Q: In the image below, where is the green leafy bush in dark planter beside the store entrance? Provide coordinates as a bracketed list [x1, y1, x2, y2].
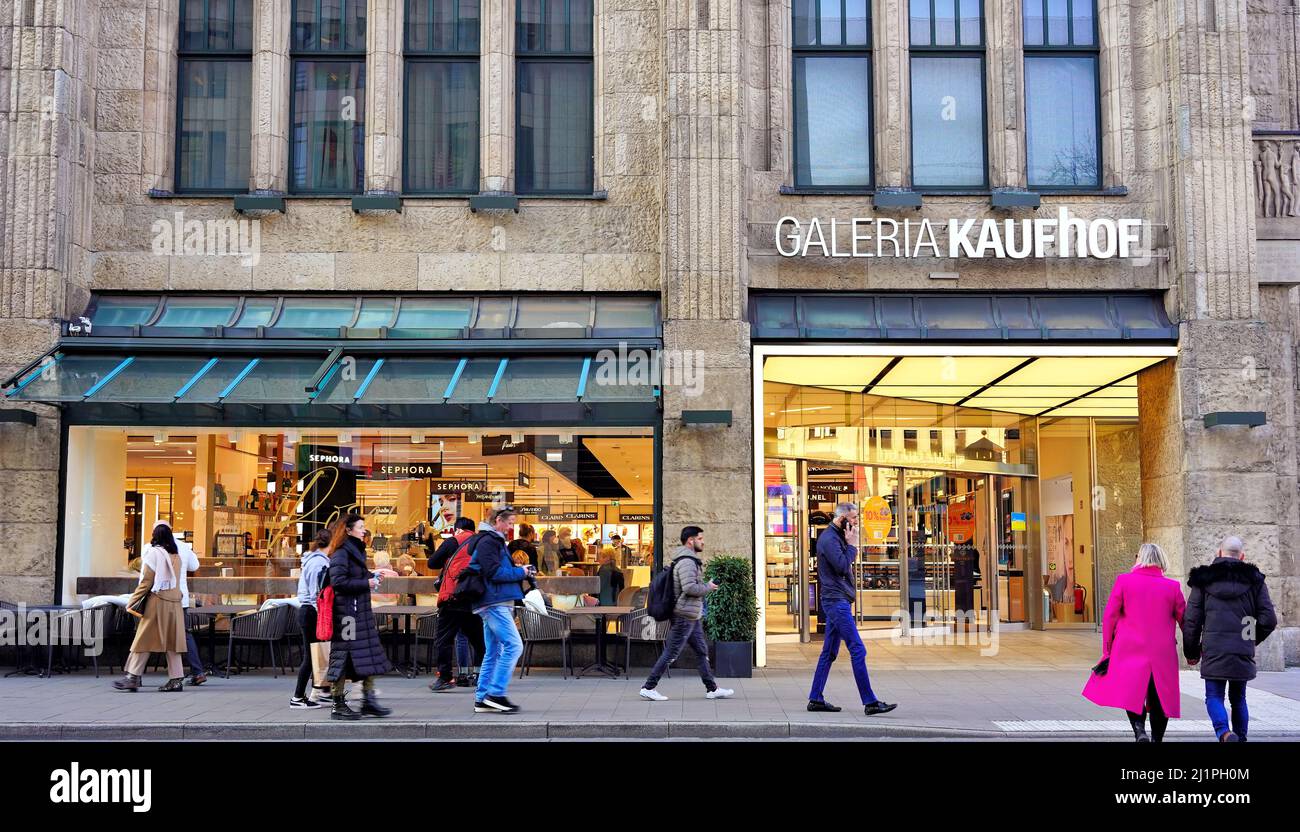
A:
[705, 555, 758, 679]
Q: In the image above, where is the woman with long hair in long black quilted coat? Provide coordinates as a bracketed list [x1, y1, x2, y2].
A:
[325, 514, 393, 719]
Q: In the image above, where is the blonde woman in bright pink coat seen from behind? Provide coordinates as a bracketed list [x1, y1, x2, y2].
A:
[1083, 543, 1187, 742]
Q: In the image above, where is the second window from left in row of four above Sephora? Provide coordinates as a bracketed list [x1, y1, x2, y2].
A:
[289, 0, 365, 194]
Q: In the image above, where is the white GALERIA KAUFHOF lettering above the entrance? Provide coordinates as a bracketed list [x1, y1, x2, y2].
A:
[776, 208, 1143, 260]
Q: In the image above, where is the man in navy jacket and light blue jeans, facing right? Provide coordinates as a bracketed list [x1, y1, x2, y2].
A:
[467, 507, 536, 714]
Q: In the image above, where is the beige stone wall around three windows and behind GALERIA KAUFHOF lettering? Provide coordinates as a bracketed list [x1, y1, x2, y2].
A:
[745, 0, 1173, 291]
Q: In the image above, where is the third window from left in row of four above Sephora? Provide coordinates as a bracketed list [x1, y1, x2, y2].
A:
[402, 0, 478, 194]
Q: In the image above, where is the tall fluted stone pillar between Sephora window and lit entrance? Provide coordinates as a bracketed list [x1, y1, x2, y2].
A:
[662, 0, 767, 555]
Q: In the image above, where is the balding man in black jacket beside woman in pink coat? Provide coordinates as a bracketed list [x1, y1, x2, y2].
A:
[1183, 537, 1278, 742]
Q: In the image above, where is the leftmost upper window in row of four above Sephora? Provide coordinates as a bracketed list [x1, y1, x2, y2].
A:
[176, 0, 252, 192]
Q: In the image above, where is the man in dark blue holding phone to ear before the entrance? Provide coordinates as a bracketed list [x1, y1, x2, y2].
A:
[809, 503, 898, 716]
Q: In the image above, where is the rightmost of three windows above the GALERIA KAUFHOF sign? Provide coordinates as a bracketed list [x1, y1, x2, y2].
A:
[1023, 0, 1101, 189]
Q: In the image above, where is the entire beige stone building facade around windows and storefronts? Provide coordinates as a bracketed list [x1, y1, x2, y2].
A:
[0, 0, 1300, 666]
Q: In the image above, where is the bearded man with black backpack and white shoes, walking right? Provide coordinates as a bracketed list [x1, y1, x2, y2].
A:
[641, 525, 736, 702]
